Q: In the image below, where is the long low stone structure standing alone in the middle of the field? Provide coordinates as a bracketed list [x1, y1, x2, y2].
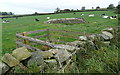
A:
[44, 18, 86, 24]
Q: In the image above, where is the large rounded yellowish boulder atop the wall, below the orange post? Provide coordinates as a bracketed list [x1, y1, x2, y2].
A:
[12, 47, 31, 61]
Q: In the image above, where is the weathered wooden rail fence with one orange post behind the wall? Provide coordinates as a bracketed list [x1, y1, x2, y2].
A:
[16, 29, 83, 50]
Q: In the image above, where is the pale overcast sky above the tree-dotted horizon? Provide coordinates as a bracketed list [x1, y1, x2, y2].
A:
[0, 0, 120, 14]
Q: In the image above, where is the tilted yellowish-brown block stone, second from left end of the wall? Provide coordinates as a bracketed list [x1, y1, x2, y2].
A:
[1, 53, 19, 67]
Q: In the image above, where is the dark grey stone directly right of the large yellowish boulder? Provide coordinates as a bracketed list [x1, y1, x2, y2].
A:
[28, 51, 44, 66]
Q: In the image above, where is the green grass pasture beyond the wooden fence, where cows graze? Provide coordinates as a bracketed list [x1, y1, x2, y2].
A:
[2, 11, 118, 54]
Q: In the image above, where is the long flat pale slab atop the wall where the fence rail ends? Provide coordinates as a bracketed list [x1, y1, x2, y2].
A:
[54, 44, 77, 52]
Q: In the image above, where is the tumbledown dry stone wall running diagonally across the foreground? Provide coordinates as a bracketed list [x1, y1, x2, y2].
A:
[0, 27, 118, 74]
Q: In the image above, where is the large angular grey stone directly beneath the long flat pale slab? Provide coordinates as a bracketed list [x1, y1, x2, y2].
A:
[55, 49, 71, 63]
